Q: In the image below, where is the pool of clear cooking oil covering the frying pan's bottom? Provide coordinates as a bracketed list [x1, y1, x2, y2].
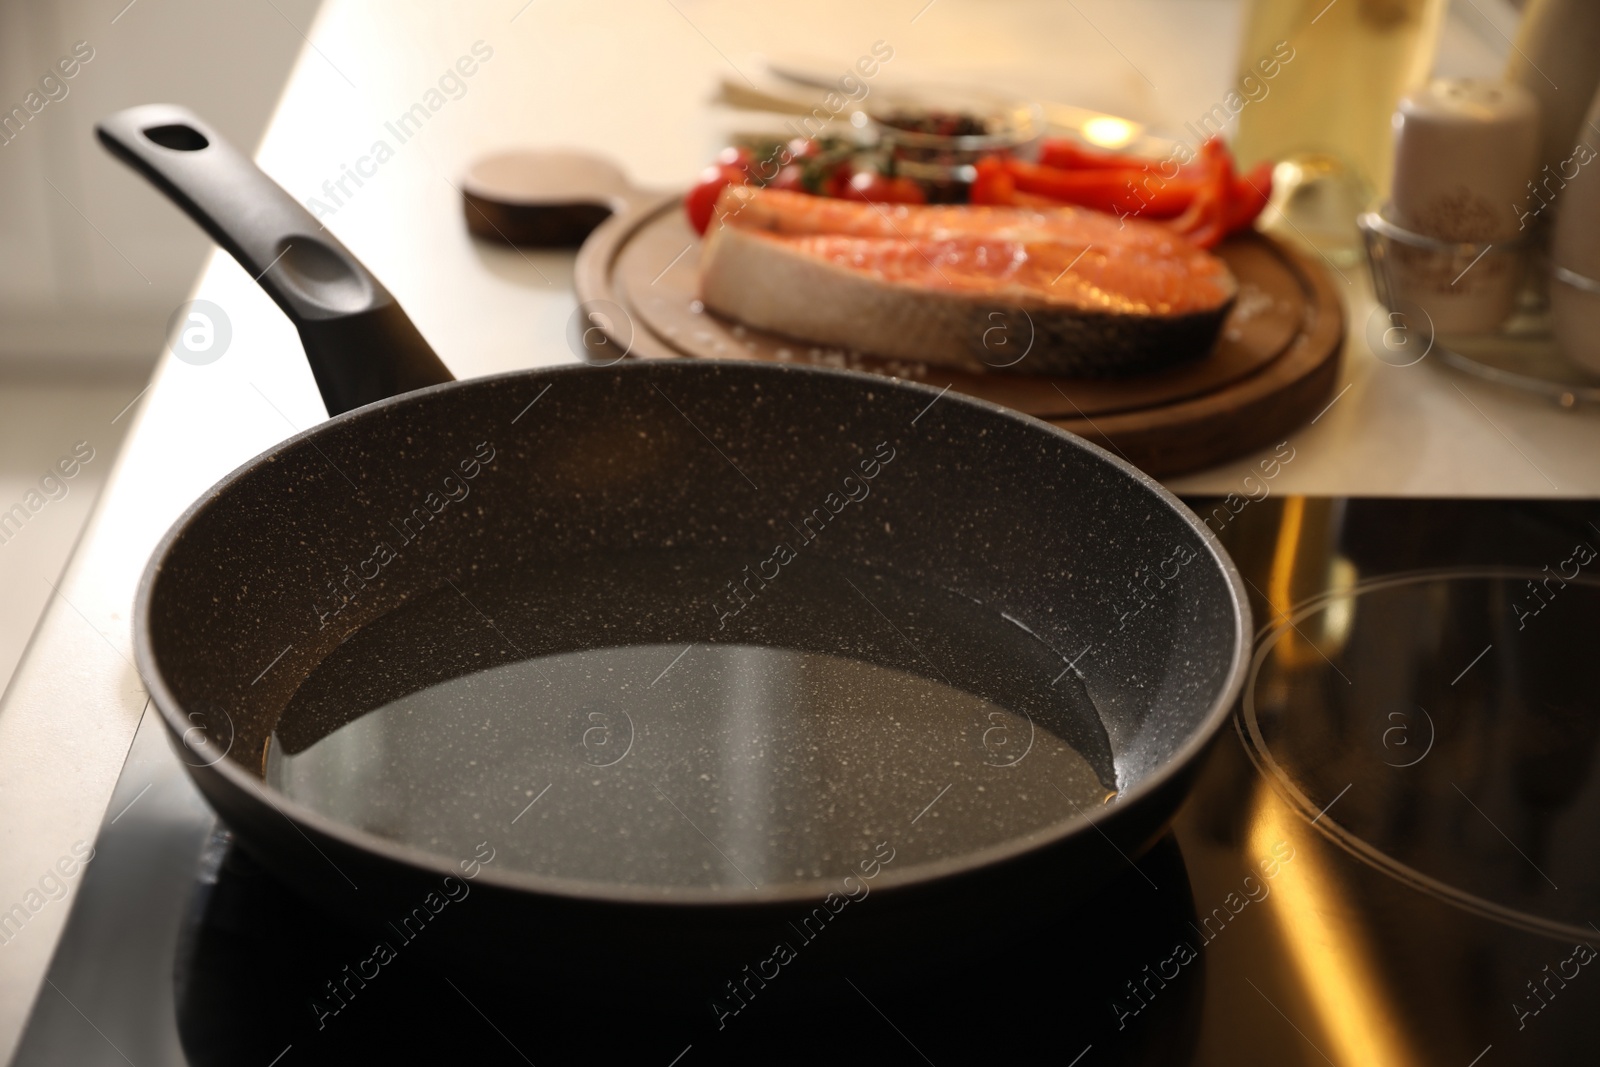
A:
[264, 553, 1114, 888]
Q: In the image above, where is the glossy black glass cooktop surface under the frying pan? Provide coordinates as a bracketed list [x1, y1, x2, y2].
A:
[16, 496, 1600, 1067]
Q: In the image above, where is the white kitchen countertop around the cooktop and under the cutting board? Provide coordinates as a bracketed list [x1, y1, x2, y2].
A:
[0, 0, 1600, 1061]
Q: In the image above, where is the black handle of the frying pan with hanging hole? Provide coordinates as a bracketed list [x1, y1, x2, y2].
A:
[94, 104, 453, 414]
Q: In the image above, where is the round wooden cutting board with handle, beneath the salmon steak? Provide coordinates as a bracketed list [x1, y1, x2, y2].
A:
[466, 152, 1344, 477]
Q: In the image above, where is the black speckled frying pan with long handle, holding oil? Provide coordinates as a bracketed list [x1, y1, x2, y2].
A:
[98, 106, 1251, 968]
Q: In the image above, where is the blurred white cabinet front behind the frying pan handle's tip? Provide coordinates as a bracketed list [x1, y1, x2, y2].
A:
[0, 0, 317, 375]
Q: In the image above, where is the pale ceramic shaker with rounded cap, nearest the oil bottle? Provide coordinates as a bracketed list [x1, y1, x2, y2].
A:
[1387, 78, 1539, 334]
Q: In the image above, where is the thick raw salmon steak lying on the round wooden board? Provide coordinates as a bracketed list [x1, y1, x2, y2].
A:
[701, 186, 1238, 378]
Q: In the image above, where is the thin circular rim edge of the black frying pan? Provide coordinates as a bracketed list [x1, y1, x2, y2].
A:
[133, 358, 1253, 910]
